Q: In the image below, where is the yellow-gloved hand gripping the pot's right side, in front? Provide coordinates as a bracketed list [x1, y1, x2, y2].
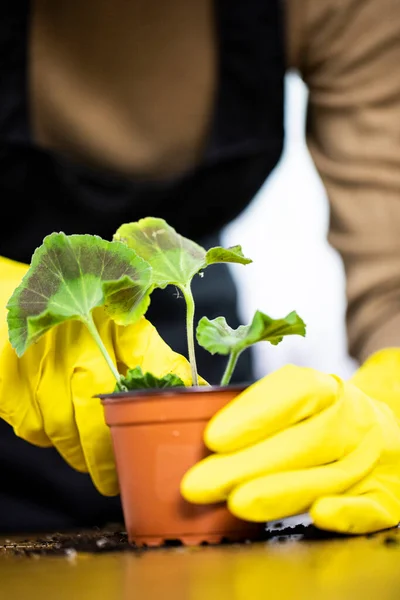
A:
[181, 349, 400, 534]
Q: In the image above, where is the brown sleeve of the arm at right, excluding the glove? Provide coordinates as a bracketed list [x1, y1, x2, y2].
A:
[287, 0, 400, 361]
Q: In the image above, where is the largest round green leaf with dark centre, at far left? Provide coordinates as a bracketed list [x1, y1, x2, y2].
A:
[7, 233, 152, 356]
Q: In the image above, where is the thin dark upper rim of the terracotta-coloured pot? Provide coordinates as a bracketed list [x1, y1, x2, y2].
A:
[94, 381, 254, 402]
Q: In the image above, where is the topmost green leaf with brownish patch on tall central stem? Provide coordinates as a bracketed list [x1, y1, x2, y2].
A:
[114, 217, 251, 288]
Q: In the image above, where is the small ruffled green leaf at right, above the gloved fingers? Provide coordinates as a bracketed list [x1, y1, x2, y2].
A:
[196, 311, 306, 355]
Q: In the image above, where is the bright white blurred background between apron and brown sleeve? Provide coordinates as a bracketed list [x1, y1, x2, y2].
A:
[223, 73, 357, 378]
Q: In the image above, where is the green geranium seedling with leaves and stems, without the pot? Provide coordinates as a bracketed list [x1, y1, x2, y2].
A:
[7, 217, 306, 391]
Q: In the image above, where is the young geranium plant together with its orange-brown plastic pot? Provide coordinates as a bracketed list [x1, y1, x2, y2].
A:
[8, 217, 305, 546]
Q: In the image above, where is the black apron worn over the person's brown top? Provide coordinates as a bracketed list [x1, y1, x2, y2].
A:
[0, 0, 284, 533]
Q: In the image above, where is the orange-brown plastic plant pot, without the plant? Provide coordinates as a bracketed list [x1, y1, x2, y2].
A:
[100, 386, 265, 546]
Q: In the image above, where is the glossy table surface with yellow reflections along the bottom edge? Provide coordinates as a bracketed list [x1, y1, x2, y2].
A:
[0, 529, 400, 600]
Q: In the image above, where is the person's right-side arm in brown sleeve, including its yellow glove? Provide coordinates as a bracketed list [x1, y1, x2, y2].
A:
[181, 0, 400, 535]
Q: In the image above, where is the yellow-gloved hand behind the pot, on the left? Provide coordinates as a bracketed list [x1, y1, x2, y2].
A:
[0, 258, 191, 495]
